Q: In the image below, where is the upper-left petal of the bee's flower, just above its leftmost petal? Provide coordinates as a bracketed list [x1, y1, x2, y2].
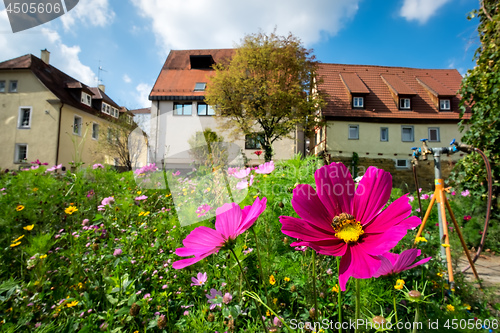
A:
[292, 184, 334, 231]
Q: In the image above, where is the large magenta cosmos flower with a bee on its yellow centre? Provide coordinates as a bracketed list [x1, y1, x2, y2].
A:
[280, 163, 421, 290]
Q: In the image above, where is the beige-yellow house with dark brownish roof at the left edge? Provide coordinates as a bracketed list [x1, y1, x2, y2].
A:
[0, 50, 133, 169]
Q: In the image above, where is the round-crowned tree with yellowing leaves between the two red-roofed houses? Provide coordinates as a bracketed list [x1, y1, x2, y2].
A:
[205, 32, 324, 161]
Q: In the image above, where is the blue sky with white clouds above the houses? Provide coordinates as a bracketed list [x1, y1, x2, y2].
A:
[0, 0, 479, 109]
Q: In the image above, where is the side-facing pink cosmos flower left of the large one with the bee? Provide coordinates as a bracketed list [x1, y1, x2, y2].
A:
[172, 197, 267, 269]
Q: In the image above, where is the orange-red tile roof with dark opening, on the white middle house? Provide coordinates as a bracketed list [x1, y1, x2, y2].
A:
[149, 49, 234, 99]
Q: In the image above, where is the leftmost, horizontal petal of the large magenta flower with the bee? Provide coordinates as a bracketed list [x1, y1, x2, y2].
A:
[280, 216, 335, 242]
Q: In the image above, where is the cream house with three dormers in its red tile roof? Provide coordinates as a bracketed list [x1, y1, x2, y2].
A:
[313, 64, 468, 186]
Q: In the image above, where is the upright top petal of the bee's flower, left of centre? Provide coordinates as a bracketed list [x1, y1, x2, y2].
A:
[314, 162, 355, 216]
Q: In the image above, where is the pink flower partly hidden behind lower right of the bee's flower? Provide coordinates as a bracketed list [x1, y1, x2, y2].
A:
[373, 249, 432, 277]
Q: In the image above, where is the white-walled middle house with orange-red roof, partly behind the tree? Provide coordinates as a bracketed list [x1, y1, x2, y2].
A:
[149, 49, 304, 168]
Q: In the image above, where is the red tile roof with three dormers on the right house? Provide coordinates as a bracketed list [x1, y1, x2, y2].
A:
[319, 64, 467, 121]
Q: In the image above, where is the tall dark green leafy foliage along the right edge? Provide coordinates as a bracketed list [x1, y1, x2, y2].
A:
[455, 0, 500, 197]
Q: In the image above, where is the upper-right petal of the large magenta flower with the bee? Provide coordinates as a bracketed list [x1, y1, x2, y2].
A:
[353, 166, 392, 224]
